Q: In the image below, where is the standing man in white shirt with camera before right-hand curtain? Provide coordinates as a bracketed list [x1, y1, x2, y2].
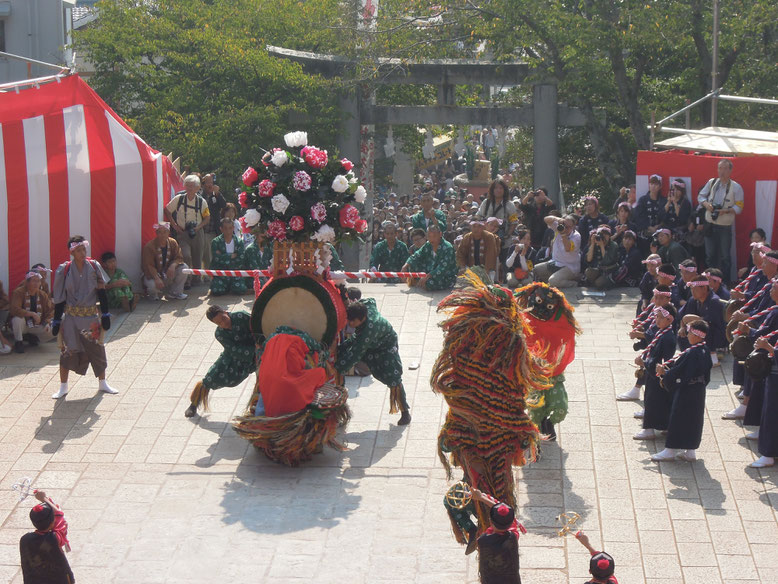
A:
[697, 159, 743, 282]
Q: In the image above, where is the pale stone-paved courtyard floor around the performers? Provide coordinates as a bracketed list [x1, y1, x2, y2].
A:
[0, 284, 778, 584]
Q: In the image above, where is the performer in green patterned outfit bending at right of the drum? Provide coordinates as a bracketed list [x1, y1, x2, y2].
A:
[335, 298, 411, 426]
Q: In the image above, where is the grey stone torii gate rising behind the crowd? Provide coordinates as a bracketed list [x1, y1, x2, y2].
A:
[267, 46, 586, 266]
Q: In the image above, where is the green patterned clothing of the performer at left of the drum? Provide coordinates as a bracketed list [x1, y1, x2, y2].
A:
[203, 310, 257, 389]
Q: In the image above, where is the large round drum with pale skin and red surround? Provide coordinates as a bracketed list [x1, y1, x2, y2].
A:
[251, 274, 346, 346]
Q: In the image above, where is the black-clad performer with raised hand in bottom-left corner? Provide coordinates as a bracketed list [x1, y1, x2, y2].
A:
[19, 491, 75, 584]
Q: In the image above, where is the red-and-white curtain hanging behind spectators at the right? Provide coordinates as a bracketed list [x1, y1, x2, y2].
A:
[635, 150, 778, 266]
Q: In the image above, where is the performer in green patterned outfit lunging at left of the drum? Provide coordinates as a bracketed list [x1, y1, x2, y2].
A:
[184, 304, 257, 418]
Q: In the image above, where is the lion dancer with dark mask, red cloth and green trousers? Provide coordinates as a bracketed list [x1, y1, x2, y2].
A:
[515, 282, 581, 440]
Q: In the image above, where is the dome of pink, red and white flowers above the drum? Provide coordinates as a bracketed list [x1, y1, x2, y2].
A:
[238, 132, 367, 243]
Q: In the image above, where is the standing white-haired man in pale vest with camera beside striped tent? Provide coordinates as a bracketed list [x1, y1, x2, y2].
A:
[165, 174, 211, 289]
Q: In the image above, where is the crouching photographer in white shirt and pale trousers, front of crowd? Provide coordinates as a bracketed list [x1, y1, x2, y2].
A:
[534, 215, 581, 288]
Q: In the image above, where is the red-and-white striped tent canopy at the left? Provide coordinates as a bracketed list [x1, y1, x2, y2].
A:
[0, 75, 182, 290]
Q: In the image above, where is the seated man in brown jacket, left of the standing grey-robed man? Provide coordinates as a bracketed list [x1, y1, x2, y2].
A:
[11, 272, 54, 353]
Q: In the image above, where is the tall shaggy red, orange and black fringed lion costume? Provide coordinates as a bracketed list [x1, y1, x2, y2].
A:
[430, 271, 550, 543]
